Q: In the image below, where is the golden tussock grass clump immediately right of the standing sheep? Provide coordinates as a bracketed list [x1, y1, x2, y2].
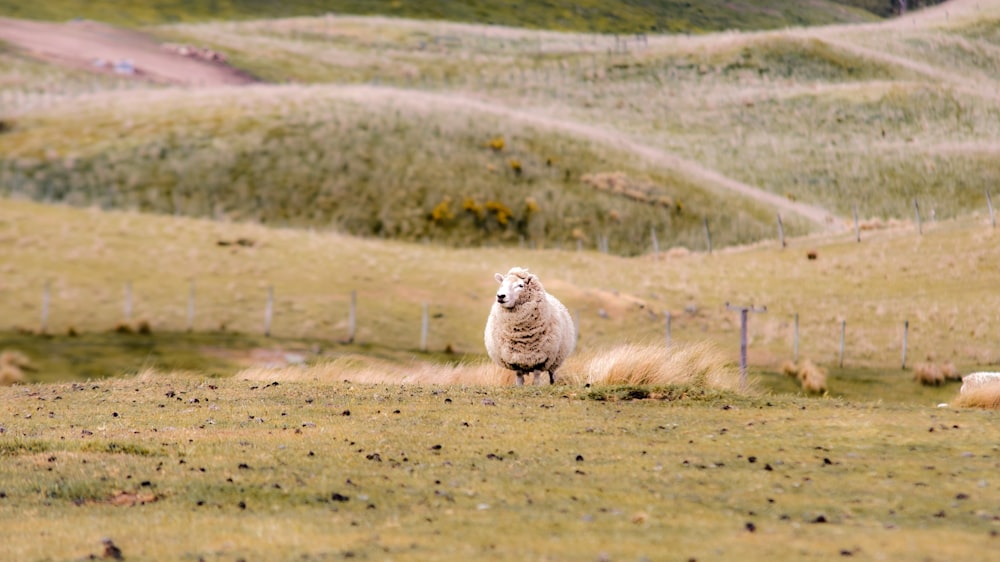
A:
[561, 342, 740, 391]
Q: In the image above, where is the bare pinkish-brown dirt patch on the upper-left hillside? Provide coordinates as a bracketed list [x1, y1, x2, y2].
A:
[0, 18, 254, 86]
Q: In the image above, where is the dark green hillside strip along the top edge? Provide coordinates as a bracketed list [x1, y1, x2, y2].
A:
[0, 0, 876, 33]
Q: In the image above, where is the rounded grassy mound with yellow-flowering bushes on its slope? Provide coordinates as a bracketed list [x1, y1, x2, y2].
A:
[0, 87, 788, 254]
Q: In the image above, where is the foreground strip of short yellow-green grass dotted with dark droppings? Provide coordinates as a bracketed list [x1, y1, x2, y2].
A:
[0, 375, 1000, 560]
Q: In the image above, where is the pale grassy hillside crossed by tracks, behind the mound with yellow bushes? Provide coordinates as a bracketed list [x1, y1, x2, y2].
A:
[156, 3, 1000, 218]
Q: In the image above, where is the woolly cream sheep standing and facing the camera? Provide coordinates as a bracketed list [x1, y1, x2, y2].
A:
[485, 267, 576, 386]
